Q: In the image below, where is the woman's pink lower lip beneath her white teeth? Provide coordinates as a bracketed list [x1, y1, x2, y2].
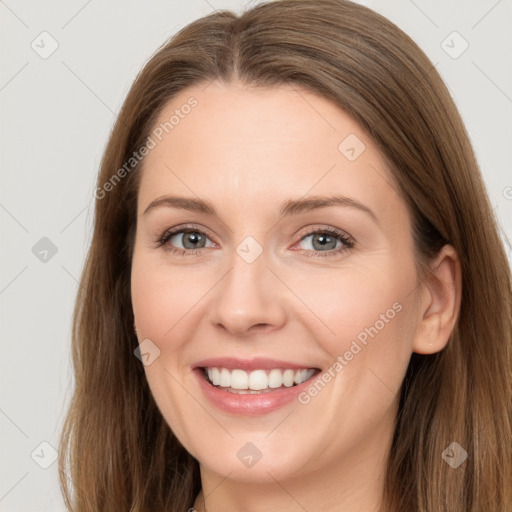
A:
[193, 368, 316, 416]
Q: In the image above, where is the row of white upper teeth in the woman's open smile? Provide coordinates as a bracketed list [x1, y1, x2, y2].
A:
[207, 368, 315, 391]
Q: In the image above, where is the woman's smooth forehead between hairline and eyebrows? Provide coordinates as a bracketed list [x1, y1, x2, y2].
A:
[139, 81, 400, 219]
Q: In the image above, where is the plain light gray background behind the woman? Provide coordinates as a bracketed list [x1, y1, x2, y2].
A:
[0, 0, 512, 512]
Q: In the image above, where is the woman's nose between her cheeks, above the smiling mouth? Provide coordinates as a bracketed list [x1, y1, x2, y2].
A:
[210, 246, 287, 337]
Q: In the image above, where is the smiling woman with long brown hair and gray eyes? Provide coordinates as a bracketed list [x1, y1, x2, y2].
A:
[60, 0, 512, 512]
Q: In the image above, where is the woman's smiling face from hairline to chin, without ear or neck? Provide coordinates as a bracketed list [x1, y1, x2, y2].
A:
[131, 82, 420, 482]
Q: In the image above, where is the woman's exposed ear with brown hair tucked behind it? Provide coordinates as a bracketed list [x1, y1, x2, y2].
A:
[413, 245, 462, 354]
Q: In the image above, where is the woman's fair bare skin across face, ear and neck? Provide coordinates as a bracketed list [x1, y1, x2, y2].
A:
[131, 81, 460, 512]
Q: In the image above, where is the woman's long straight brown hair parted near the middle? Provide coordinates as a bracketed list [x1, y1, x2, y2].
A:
[59, 0, 512, 512]
